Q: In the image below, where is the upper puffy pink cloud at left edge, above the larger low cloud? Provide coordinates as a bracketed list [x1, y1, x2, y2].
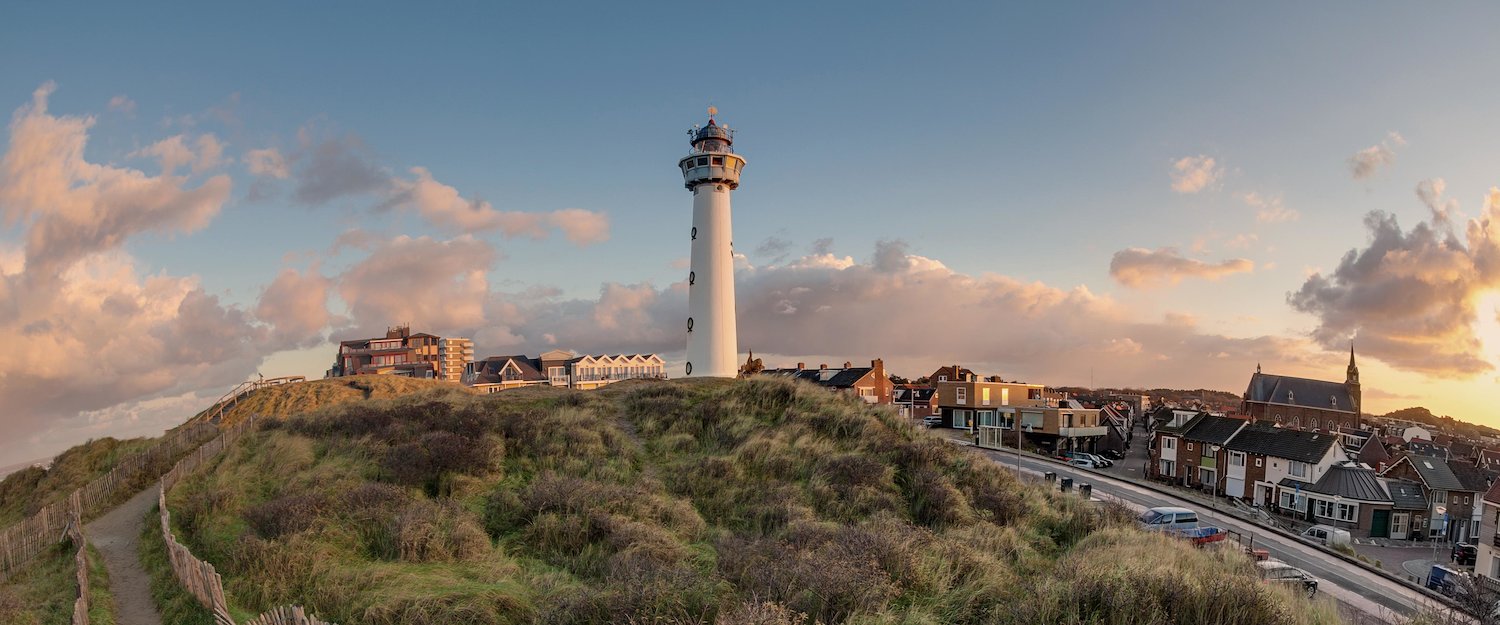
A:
[0, 82, 230, 276]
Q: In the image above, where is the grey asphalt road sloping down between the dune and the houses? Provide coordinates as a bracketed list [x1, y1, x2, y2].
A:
[954, 440, 1446, 621]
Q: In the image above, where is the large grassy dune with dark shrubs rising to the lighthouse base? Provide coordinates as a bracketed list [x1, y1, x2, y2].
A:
[161, 374, 1338, 625]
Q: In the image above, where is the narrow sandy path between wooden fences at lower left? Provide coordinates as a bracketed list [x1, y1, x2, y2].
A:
[84, 484, 162, 625]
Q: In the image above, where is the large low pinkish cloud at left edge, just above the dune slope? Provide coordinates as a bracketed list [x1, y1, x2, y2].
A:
[0, 250, 264, 459]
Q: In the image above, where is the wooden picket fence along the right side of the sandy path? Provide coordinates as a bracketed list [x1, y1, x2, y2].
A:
[156, 417, 332, 625]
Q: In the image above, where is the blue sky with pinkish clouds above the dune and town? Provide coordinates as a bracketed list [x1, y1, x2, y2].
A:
[0, 3, 1500, 465]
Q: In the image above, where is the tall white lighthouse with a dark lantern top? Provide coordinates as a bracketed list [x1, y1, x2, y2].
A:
[677, 106, 746, 378]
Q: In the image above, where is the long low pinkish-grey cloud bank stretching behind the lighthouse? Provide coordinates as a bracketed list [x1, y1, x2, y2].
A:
[423, 241, 1340, 387]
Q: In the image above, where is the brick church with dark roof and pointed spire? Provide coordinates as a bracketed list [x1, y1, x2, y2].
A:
[1239, 345, 1361, 430]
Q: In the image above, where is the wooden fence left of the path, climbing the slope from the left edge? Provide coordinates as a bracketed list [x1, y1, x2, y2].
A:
[0, 424, 218, 582]
